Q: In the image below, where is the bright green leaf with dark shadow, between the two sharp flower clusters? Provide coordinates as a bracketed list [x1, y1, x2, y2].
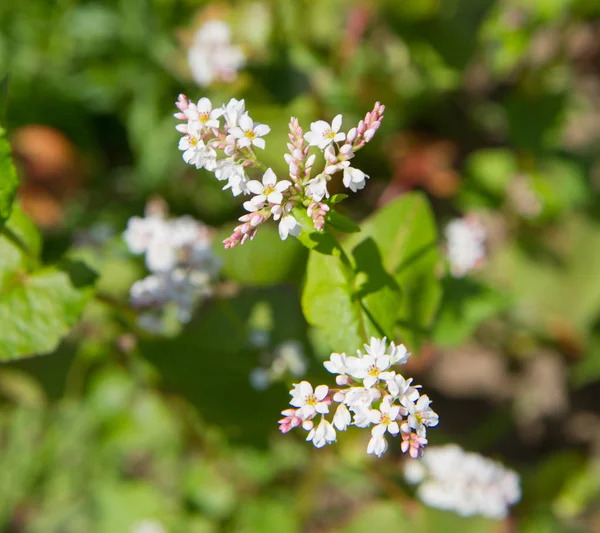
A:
[302, 194, 441, 353]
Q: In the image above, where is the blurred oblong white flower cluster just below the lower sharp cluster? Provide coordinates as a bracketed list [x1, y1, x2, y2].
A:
[404, 444, 521, 519]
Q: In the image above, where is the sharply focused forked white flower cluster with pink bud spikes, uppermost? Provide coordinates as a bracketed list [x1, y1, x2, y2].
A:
[175, 95, 385, 248]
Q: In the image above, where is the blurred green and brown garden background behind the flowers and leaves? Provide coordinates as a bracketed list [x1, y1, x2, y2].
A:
[0, 0, 600, 533]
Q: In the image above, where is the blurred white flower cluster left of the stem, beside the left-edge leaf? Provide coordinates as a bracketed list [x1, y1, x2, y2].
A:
[123, 201, 220, 332]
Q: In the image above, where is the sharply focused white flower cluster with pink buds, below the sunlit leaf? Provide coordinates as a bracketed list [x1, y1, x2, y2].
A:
[279, 338, 438, 458]
